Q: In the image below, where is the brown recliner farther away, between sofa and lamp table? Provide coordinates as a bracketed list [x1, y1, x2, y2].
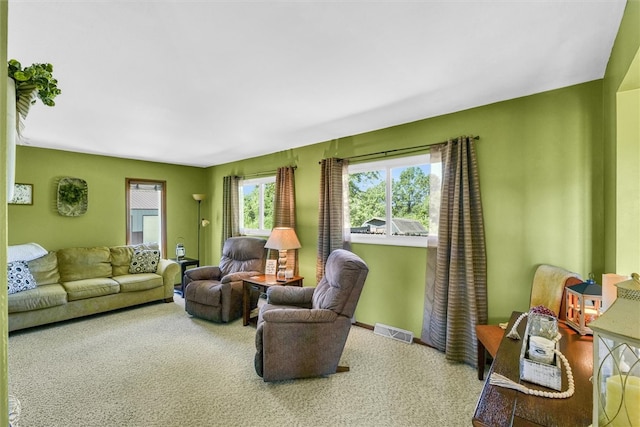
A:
[184, 237, 266, 323]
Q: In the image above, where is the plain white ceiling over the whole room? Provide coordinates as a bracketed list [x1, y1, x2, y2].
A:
[8, 0, 626, 167]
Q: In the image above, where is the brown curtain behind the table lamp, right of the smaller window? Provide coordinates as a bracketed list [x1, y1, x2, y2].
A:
[273, 166, 300, 276]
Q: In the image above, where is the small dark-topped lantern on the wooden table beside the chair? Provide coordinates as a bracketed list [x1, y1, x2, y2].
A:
[565, 277, 602, 335]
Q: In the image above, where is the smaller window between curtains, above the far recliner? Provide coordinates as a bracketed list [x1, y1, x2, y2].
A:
[238, 176, 276, 236]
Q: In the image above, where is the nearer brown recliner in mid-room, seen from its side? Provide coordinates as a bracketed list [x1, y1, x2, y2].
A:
[255, 249, 369, 381]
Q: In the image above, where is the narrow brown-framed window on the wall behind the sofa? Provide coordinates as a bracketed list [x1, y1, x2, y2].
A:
[126, 178, 167, 256]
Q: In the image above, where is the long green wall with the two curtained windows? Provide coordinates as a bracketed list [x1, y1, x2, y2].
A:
[208, 81, 603, 330]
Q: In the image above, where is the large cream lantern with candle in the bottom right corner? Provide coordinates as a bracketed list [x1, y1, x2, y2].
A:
[589, 273, 640, 427]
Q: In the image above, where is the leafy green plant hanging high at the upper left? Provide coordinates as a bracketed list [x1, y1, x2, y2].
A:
[8, 59, 62, 130]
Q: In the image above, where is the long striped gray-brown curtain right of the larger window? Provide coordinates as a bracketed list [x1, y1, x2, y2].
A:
[421, 137, 487, 366]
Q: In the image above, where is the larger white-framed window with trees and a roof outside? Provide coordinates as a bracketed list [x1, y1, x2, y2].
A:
[348, 154, 442, 247]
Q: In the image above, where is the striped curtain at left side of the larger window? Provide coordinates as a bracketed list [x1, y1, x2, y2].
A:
[316, 158, 349, 282]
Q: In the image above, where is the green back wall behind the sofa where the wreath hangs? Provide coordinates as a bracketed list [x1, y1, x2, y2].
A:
[8, 147, 207, 258]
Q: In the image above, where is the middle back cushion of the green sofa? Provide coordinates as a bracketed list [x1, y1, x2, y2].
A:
[57, 246, 112, 282]
